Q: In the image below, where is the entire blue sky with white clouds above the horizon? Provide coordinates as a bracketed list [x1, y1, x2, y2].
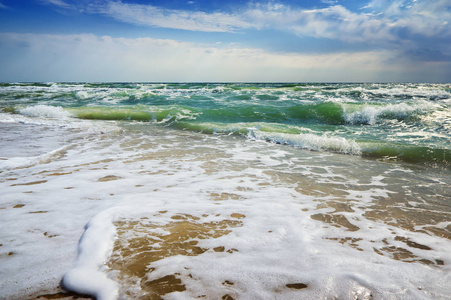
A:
[0, 0, 451, 83]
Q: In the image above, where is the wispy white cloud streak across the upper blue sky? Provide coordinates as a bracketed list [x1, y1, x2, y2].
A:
[42, 0, 451, 47]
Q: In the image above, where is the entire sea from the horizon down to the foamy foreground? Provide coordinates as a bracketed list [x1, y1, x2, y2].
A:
[0, 83, 451, 299]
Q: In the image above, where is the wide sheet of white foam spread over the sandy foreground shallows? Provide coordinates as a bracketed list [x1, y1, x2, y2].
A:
[0, 126, 451, 299]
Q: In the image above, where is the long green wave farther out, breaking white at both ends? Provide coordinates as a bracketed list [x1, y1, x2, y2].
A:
[10, 102, 434, 125]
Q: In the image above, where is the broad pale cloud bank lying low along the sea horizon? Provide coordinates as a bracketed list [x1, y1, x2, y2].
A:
[0, 33, 451, 82]
